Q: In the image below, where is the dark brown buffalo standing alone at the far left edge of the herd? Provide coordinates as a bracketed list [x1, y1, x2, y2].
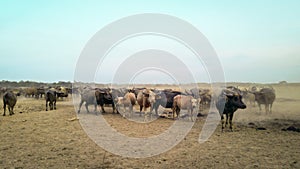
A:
[3, 91, 17, 116]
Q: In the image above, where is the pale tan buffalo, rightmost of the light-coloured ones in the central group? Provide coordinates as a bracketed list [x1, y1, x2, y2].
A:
[173, 95, 198, 121]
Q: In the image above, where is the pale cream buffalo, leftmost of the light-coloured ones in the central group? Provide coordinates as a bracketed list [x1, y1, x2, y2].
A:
[116, 93, 136, 117]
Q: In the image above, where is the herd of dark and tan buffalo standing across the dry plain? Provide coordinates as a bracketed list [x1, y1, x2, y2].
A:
[0, 86, 276, 131]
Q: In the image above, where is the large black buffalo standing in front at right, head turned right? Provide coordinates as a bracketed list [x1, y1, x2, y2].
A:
[216, 89, 246, 131]
